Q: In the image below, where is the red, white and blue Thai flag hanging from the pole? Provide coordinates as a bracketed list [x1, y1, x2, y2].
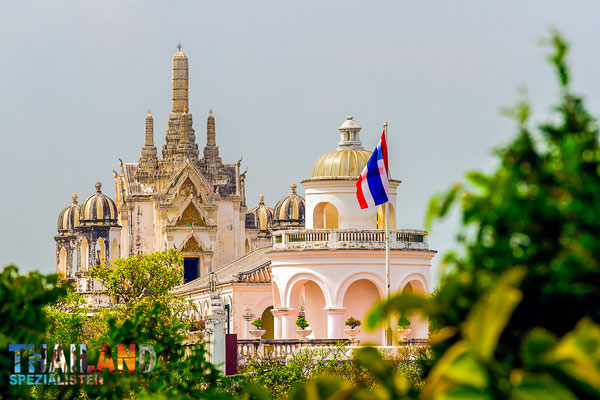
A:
[356, 131, 388, 208]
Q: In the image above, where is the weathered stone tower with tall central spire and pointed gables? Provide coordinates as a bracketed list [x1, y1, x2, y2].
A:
[114, 44, 252, 281]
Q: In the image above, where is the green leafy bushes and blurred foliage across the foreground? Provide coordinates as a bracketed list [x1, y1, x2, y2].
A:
[0, 32, 600, 400]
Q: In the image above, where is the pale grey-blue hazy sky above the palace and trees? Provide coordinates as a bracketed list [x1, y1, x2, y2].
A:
[0, 0, 600, 280]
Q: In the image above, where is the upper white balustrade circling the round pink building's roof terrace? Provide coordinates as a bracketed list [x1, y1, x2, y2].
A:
[273, 229, 429, 250]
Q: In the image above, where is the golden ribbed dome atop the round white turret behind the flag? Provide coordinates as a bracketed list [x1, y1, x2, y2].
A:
[310, 149, 371, 178]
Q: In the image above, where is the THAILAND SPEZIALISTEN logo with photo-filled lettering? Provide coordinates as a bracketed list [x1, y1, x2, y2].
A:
[8, 344, 156, 385]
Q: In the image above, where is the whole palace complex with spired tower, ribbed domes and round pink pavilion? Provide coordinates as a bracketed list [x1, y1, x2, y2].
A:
[55, 43, 435, 344]
